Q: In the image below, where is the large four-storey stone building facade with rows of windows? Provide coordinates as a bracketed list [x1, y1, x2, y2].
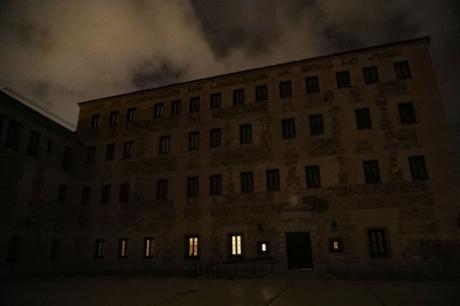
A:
[2, 38, 460, 273]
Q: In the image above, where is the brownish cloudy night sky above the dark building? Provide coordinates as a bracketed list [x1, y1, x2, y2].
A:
[0, 0, 460, 144]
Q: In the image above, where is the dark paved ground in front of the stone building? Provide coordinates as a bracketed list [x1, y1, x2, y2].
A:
[0, 276, 460, 306]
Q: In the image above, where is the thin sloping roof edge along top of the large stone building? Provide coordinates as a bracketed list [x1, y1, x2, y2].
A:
[78, 36, 431, 105]
